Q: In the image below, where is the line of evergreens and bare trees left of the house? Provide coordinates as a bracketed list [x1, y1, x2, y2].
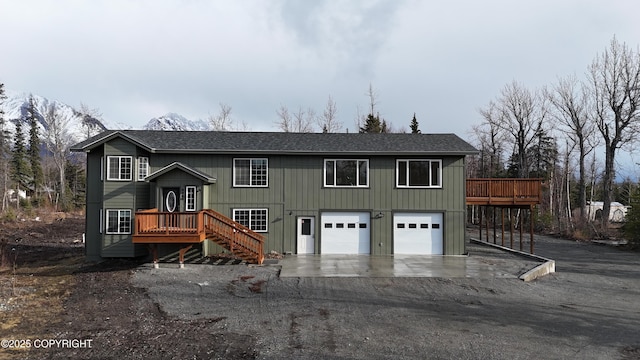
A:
[0, 83, 89, 212]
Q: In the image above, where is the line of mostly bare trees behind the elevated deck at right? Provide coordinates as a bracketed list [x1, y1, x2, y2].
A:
[468, 37, 640, 236]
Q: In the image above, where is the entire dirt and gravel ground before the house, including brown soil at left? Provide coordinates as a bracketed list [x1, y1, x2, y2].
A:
[5, 218, 640, 359]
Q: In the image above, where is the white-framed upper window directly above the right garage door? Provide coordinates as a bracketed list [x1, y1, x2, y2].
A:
[396, 159, 442, 188]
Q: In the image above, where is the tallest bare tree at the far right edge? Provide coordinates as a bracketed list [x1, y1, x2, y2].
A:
[588, 37, 640, 228]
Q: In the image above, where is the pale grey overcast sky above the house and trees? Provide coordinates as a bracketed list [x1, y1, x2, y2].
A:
[0, 0, 640, 138]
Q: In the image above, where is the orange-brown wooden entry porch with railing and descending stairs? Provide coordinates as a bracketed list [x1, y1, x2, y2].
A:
[132, 209, 264, 266]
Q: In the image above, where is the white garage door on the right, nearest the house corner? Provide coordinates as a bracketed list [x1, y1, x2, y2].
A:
[393, 213, 443, 255]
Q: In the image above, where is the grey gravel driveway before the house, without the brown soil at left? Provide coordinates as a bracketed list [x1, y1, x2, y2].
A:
[133, 236, 640, 359]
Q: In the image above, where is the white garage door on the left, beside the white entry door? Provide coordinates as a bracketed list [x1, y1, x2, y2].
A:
[320, 212, 371, 254]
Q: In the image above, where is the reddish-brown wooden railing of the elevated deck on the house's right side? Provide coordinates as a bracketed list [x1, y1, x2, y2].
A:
[467, 178, 542, 207]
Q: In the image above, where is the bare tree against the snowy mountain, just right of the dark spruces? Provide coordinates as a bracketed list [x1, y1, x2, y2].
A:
[45, 104, 72, 205]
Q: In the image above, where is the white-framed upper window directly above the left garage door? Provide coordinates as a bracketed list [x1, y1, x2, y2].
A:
[324, 159, 369, 187]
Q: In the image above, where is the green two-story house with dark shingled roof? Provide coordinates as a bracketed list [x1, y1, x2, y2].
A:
[72, 130, 477, 259]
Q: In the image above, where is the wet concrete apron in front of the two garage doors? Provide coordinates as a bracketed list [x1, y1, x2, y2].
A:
[278, 239, 540, 278]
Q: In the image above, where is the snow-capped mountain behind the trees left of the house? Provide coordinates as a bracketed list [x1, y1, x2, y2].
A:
[2, 90, 107, 144]
